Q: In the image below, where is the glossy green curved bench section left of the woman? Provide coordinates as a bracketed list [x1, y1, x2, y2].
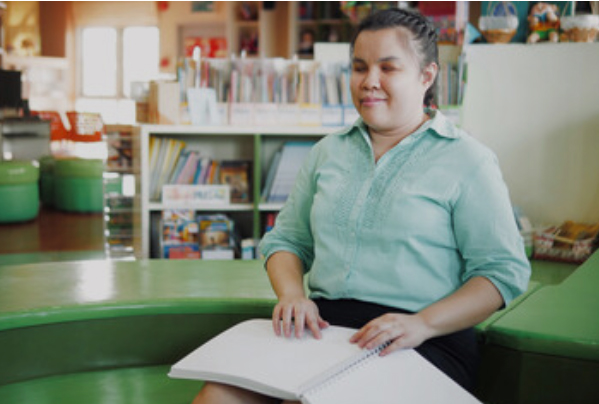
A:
[0, 260, 275, 404]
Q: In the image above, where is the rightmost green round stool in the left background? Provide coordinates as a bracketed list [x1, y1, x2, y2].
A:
[54, 159, 104, 213]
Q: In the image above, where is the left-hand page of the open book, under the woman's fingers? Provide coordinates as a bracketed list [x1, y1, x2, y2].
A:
[169, 320, 365, 399]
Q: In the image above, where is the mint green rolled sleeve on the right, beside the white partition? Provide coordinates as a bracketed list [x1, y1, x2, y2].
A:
[453, 154, 531, 306]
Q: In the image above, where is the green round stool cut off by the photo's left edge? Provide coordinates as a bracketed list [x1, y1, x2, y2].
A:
[0, 161, 40, 223]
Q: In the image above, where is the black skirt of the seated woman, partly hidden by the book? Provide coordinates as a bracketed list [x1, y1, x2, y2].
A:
[314, 298, 479, 392]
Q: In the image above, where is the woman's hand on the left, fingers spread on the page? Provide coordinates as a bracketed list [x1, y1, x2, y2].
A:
[272, 296, 329, 339]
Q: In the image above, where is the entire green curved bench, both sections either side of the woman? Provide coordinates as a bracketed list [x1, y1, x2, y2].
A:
[0, 254, 599, 404]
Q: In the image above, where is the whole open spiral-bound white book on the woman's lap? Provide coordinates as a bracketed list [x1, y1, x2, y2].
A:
[169, 319, 480, 404]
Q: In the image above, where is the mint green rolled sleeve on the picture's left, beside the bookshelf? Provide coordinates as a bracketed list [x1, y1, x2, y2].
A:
[259, 145, 318, 272]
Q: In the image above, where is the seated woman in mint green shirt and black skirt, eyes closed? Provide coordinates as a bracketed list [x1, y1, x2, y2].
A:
[192, 9, 530, 403]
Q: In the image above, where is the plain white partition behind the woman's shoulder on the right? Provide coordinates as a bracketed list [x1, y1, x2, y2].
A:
[463, 43, 599, 225]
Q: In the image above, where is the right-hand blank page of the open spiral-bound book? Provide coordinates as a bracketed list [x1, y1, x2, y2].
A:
[302, 349, 480, 404]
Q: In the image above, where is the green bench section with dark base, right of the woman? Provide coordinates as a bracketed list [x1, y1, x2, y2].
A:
[480, 252, 599, 404]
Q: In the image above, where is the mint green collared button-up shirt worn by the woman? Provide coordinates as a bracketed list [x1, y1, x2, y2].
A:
[260, 111, 530, 311]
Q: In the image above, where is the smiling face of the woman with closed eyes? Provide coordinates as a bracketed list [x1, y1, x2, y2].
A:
[350, 28, 436, 136]
